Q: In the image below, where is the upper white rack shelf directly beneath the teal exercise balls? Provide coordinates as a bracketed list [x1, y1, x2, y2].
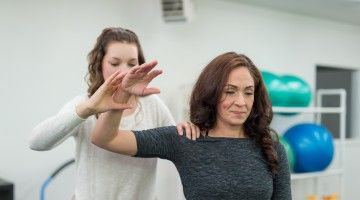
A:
[273, 107, 345, 113]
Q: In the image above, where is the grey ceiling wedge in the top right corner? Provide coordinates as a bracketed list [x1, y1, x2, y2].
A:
[226, 0, 360, 26]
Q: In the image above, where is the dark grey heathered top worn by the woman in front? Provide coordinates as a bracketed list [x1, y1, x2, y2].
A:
[133, 126, 291, 200]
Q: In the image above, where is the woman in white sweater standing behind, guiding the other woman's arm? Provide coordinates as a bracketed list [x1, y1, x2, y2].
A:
[29, 28, 198, 200]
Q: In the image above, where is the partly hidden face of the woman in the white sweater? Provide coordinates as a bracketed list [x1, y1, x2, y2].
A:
[102, 42, 139, 80]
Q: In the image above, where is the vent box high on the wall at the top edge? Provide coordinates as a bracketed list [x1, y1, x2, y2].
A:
[161, 0, 193, 22]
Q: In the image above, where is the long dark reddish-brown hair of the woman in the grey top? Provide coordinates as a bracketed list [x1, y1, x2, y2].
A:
[190, 52, 279, 175]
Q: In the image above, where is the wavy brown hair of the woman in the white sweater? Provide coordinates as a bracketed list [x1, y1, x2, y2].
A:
[87, 27, 145, 97]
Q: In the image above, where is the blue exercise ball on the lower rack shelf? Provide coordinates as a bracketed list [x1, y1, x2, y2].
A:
[283, 123, 334, 173]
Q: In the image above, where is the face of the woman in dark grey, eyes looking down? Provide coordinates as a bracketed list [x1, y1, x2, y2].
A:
[216, 67, 255, 127]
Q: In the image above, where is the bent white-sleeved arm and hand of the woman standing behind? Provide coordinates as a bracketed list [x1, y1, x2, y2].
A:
[29, 69, 130, 151]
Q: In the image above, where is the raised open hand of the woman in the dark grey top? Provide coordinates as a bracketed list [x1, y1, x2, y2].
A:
[117, 61, 162, 96]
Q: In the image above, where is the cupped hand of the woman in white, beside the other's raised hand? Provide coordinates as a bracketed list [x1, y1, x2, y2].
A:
[76, 71, 132, 119]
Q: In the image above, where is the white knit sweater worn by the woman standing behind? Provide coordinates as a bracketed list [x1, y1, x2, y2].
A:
[29, 95, 183, 200]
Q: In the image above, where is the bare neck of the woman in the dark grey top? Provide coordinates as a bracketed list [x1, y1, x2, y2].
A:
[208, 124, 246, 138]
